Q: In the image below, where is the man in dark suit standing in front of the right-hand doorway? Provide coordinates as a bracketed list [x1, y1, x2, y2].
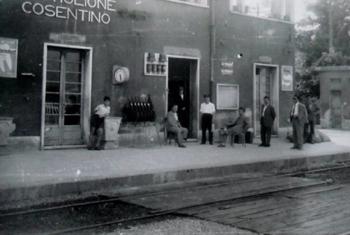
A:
[259, 96, 276, 147]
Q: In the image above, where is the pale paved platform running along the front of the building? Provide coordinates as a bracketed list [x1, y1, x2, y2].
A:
[0, 131, 350, 189]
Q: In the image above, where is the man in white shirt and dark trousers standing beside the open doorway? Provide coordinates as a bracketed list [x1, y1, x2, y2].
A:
[200, 95, 215, 145]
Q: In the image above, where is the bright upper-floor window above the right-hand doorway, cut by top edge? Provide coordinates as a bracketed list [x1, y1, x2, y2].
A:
[230, 0, 294, 21]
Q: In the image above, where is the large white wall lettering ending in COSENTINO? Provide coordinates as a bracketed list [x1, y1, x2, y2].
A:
[22, 0, 117, 24]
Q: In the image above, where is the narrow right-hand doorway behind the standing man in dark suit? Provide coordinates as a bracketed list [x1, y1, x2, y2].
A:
[254, 64, 279, 136]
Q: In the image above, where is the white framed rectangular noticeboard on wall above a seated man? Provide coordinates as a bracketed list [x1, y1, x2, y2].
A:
[216, 84, 239, 110]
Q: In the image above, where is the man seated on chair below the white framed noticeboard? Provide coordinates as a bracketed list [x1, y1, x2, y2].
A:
[218, 107, 249, 147]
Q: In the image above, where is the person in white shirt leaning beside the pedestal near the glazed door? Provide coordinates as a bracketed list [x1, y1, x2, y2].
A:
[88, 96, 111, 150]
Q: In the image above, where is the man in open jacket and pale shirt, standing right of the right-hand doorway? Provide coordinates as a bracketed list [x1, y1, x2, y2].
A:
[290, 96, 308, 150]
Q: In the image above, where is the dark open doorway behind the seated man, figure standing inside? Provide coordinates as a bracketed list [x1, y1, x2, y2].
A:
[166, 56, 199, 138]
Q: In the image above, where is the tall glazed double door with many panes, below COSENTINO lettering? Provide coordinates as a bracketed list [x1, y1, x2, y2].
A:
[44, 47, 84, 146]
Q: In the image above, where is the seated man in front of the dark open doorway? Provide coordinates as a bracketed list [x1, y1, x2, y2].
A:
[166, 105, 188, 148]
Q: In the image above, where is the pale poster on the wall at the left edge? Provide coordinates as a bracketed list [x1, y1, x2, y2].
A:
[0, 38, 18, 78]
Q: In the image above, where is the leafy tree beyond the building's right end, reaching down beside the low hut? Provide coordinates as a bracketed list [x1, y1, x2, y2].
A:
[296, 0, 350, 97]
